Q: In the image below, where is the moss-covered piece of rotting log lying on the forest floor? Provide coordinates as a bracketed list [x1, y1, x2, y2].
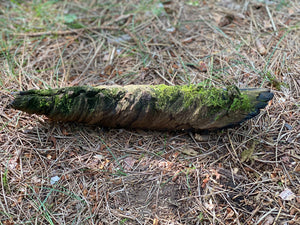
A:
[11, 84, 273, 130]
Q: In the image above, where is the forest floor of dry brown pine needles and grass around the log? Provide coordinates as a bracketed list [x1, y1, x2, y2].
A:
[0, 0, 300, 225]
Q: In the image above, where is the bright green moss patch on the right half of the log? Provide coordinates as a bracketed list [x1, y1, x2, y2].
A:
[153, 84, 252, 114]
